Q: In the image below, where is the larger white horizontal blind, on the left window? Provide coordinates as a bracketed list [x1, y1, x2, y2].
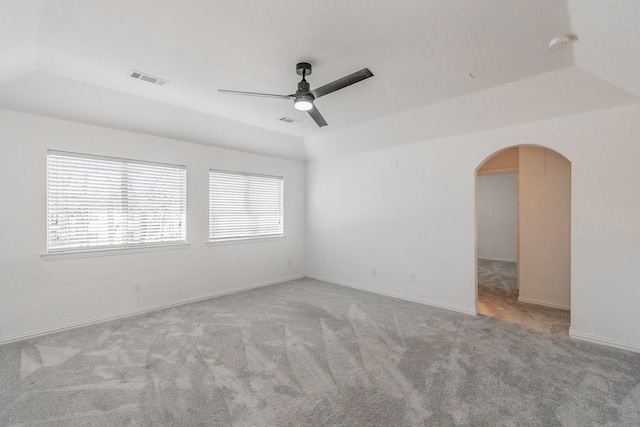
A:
[47, 151, 187, 252]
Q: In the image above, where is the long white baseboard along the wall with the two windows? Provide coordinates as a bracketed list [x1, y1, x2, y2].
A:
[0, 274, 305, 345]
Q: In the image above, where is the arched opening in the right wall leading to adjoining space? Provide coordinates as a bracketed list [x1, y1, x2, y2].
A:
[476, 145, 571, 334]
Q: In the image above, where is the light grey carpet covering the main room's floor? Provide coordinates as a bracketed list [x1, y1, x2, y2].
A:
[0, 279, 640, 426]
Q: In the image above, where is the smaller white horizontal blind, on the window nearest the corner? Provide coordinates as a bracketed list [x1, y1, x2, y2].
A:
[209, 170, 284, 241]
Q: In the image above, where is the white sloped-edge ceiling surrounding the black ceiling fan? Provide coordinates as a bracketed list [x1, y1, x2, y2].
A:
[0, 0, 640, 158]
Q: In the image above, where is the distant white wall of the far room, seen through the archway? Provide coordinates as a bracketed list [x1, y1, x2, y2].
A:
[476, 173, 518, 262]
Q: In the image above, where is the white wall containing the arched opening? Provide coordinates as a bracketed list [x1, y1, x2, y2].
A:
[306, 105, 640, 351]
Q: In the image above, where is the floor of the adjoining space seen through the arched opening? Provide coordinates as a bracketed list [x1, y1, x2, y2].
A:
[478, 259, 570, 335]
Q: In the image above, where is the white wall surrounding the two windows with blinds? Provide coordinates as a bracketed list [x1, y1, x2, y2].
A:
[0, 110, 305, 342]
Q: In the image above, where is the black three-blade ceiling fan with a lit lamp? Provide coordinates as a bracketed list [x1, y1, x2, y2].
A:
[218, 62, 373, 127]
